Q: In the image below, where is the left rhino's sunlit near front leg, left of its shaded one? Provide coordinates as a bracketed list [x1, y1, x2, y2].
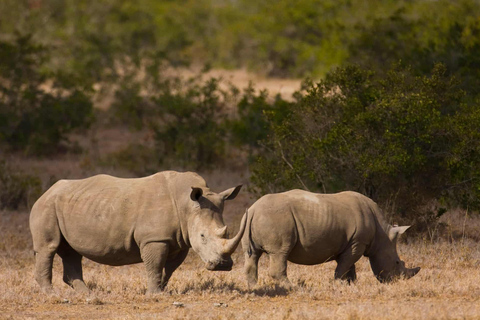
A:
[141, 242, 168, 293]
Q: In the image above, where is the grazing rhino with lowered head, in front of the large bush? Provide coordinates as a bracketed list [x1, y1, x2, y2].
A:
[242, 190, 420, 286]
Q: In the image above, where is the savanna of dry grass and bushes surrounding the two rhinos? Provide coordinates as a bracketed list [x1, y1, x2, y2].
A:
[0, 0, 480, 319]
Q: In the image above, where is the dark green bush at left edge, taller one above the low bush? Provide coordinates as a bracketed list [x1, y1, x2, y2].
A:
[0, 36, 93, 155]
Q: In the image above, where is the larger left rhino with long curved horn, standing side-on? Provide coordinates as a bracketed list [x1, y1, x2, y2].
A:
[30, 171, 246, 293]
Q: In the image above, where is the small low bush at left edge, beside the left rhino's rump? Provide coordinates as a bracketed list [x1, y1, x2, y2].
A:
[0, 160, 42, 210]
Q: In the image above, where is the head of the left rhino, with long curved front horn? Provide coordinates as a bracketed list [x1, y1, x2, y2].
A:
[188, 185, 246, 271]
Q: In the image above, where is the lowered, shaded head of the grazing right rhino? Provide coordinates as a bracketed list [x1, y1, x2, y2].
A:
[370, 226, 420, 282]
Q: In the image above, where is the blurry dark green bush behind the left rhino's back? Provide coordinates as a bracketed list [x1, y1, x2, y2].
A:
[112, 67, 238, 169]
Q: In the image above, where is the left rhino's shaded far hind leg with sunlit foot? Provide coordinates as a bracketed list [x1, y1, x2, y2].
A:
[57, 241, 90, 293]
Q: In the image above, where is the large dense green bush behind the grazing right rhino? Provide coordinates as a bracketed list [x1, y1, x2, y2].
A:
[252, 65, 480, 221]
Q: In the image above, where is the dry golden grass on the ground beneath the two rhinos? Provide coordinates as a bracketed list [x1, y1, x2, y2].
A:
[0, 210, 480, 319]
